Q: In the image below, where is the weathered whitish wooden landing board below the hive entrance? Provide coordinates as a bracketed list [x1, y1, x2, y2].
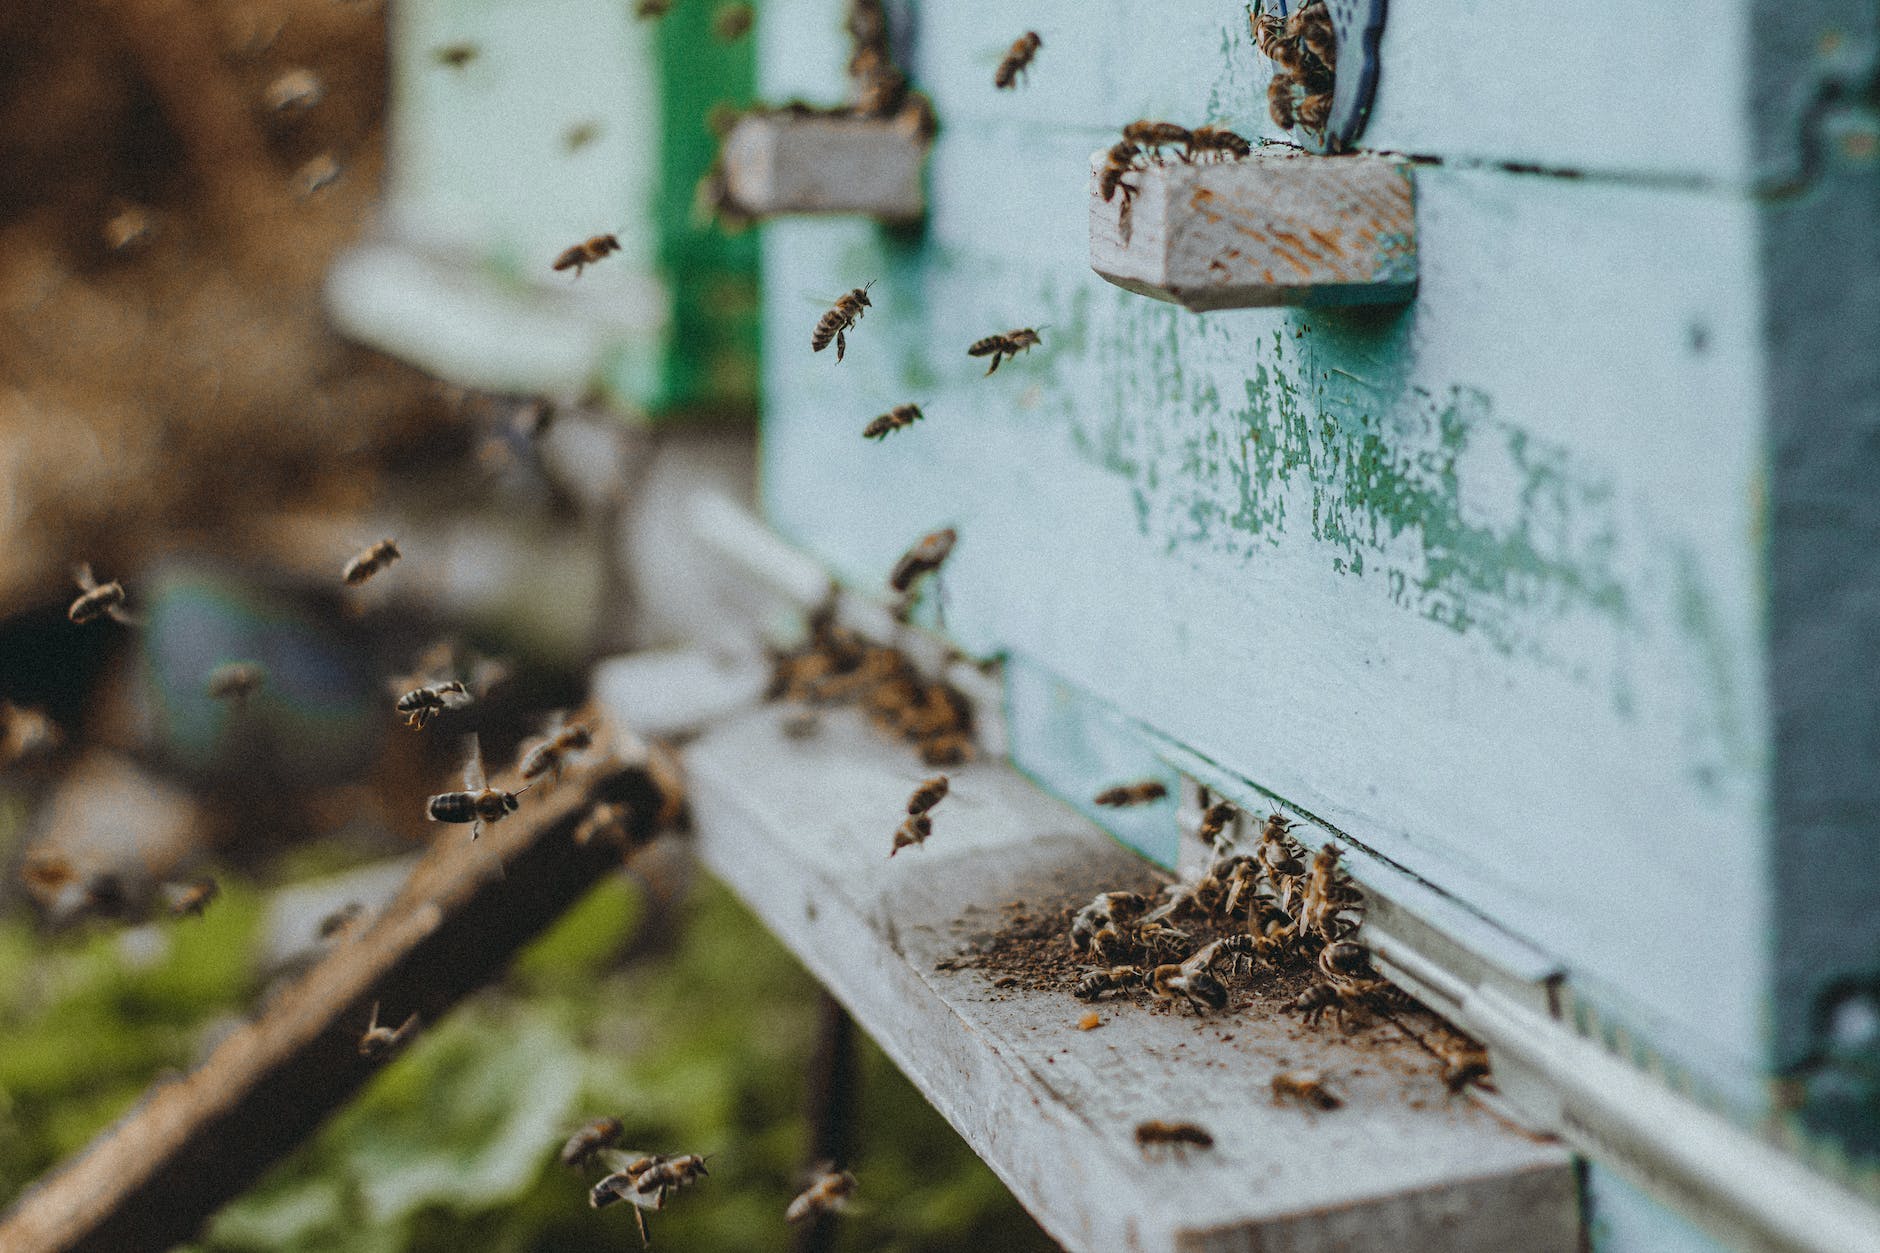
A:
[686, 707, 1579, 1253]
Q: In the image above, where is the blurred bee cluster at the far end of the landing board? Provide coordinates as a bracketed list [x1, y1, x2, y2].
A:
[767, 608, 974, 766]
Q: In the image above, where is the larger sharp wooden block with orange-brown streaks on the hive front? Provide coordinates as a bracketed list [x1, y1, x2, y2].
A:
[1090, 149, 1416, 312]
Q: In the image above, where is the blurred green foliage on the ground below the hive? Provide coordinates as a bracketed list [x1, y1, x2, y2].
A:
[0, 857, 1055, 1253]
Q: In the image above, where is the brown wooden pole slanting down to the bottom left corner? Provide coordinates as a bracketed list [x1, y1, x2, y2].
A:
[0, 752, 660, 1253]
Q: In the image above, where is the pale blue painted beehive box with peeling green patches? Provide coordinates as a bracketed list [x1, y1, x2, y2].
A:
[760, 0, 1880, 1247]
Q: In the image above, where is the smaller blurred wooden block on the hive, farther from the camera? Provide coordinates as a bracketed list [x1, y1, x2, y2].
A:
[724, 113, 927, 222]
